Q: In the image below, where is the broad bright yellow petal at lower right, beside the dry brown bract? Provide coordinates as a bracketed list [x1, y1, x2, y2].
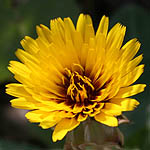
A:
[94, 112, 118, 127]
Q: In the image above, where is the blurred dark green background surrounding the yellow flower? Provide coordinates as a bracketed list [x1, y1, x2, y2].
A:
[0, 0, 150, 150]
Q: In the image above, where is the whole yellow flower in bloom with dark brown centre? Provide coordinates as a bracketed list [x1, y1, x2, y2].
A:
[6, 14, 145, 142]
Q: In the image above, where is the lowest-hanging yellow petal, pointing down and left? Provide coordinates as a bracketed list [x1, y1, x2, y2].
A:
[52, 118, 80, 142]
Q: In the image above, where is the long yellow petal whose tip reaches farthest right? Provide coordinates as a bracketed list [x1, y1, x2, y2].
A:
[115, 84, 146, 98]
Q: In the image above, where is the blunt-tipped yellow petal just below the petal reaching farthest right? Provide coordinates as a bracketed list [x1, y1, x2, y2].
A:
[110, 98, 139, 111]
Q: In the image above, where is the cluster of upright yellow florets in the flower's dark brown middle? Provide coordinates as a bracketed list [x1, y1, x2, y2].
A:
[67, 71, 94, 104]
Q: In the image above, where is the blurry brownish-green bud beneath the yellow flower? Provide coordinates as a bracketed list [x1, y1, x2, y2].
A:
[64, 118, 124, 150]
